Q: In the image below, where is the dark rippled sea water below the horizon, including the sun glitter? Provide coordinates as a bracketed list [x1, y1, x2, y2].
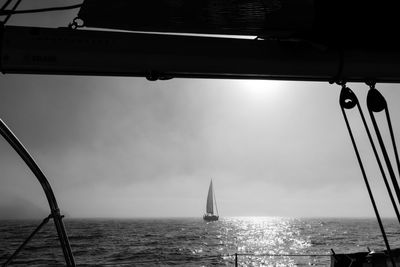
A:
[0, 217, 400, 266]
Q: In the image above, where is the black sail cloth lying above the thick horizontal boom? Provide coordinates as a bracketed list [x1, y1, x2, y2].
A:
[78, 0, 400, 49]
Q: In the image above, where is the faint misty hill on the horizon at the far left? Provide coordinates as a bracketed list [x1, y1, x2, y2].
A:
[0, 198, 50, 220]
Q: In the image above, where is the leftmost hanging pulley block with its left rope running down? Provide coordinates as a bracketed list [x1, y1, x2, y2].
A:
[339, 84, 396, 267]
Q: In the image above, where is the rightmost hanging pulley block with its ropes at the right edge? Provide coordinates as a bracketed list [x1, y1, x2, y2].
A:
[367, 85, 400, 207]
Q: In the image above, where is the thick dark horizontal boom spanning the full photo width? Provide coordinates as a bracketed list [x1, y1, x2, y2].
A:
[0, 26, 400, 82]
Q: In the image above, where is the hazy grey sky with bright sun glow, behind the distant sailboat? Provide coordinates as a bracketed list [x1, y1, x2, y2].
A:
[0, 1, 400, 218]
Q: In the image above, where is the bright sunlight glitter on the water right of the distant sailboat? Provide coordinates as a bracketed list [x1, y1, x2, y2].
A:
[216, 217, 318, 266]
